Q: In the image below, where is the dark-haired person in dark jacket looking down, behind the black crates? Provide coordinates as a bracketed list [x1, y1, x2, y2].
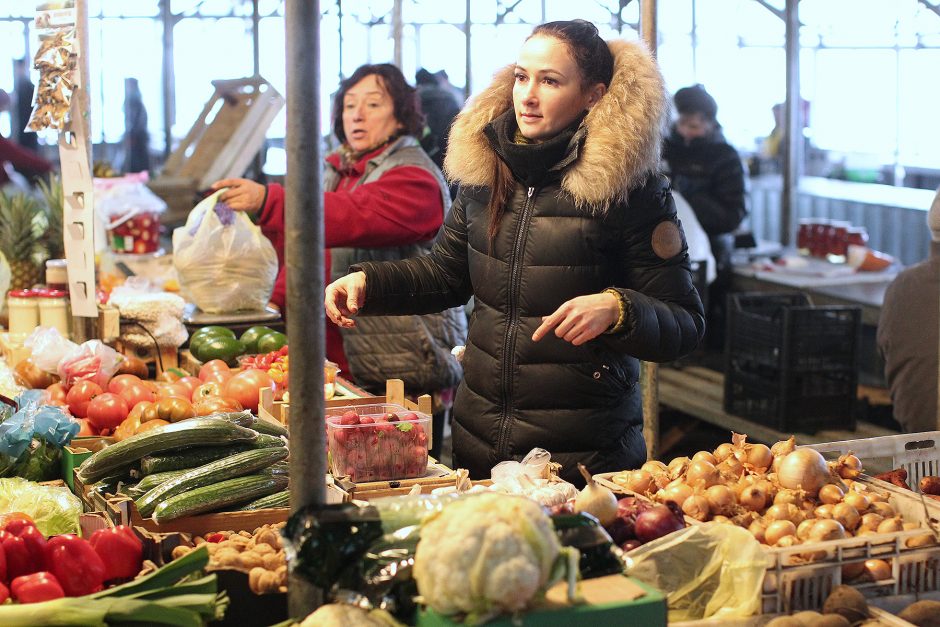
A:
[663, 85, 747, 349]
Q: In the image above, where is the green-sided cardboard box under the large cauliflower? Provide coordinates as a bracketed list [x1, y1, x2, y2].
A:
[417, 575, 666, 627]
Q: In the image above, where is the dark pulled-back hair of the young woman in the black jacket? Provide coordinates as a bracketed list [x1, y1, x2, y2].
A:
[487, 20, 614, 245]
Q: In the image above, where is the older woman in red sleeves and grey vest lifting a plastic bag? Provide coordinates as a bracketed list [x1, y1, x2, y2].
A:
[212, 63, 466, 458]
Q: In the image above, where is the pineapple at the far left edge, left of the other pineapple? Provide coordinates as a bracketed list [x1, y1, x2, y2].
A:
[0, 194, 42, 290]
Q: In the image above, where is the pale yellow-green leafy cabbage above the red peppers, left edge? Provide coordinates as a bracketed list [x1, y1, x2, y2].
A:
[0, 477, 82, 537]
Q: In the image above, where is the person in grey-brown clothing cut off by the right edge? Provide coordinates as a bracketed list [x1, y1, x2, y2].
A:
[876, 189, 940, 433]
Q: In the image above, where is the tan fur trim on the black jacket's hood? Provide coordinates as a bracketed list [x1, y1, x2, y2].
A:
[444, 40, 669, 208]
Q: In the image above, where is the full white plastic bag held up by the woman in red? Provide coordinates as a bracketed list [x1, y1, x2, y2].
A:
[173, 190, 277, 313]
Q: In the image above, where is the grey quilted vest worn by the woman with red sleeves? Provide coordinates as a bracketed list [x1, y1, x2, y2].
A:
[323, 136, 467, 394]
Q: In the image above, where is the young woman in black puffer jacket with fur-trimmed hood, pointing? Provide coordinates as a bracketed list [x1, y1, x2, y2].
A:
[325, 20, 704, 485]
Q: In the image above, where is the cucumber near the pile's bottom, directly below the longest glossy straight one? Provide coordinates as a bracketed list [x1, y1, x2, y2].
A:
[153, 475, 287, 524]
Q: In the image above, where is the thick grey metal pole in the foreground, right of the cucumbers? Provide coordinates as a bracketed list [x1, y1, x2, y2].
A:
[284, 0, 326, 619]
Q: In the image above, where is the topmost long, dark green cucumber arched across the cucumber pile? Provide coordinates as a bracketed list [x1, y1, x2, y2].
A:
[78, 418, 258, 483]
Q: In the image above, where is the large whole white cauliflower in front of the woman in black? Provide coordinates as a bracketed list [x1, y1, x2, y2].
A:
[414, 493, 578, 620]
